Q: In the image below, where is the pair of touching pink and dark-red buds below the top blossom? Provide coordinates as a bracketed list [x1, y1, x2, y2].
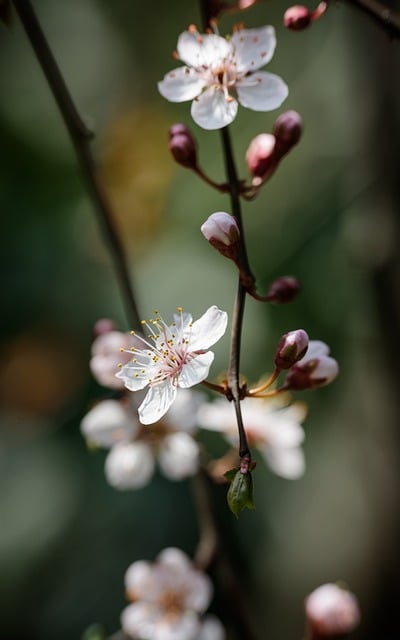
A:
[246, 111, 303, 188]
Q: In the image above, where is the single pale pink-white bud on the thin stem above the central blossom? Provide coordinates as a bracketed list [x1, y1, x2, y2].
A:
[201, 211, 240, 260]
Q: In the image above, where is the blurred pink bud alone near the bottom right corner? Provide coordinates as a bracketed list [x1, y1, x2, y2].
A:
[305, 584, 360, 639]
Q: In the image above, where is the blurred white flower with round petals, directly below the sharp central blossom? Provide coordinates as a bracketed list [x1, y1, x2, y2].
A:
[81, 390, 206, 489]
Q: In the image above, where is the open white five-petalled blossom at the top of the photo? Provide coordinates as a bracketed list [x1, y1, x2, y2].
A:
[158, 26, 288, 129]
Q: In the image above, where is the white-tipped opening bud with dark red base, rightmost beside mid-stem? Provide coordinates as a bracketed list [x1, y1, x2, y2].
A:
[285, 340, 339, 391]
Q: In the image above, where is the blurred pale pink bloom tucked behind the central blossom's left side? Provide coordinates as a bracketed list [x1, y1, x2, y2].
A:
[89, 331, 132, 389]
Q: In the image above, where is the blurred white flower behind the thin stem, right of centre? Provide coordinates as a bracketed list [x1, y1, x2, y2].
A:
[198, 394, 306, 479]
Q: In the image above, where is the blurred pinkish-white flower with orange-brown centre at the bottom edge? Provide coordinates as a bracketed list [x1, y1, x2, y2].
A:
[121, 547, 225, 640]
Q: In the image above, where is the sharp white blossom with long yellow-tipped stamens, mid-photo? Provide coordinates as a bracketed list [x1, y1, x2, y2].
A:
[117, 306, 228, 424]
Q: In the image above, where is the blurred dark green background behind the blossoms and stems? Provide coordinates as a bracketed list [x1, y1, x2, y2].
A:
[0, 0, 400, 640]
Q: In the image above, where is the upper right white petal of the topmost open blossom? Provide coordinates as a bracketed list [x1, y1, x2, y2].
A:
[231, 27, 276, 73]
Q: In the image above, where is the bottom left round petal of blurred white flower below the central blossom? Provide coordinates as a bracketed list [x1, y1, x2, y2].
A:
[105, 442, 154, 489]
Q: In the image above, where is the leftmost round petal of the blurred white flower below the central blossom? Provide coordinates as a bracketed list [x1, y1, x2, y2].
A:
[81, 400, 138, 449]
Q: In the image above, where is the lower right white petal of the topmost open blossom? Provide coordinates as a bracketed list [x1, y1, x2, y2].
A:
[236, 71, 289, 111]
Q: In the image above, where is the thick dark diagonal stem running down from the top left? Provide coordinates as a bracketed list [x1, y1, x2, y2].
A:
[12, 0, 140, 326]
